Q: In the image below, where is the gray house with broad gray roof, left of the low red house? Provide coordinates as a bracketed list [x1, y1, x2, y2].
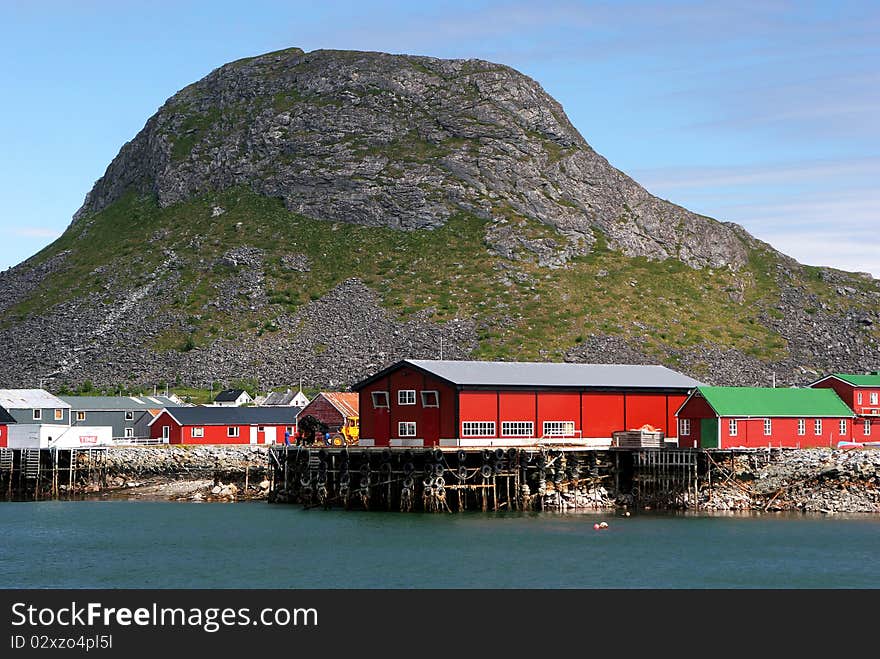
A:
[62, 396, 179, 440]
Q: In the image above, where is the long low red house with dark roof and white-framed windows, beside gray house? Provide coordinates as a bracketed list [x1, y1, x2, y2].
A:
[150, 407, 300, 444]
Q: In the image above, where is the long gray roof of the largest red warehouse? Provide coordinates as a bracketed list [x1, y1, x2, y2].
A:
[404, 359, 701, 389]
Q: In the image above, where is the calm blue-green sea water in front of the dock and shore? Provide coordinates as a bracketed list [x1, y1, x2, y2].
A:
[0, 501, 880, 588]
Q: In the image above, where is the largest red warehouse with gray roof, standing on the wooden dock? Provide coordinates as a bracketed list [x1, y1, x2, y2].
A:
[352, 359, 700, 446]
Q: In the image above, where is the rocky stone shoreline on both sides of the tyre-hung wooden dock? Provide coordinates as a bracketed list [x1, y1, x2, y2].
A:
[81, 446, 880, 514]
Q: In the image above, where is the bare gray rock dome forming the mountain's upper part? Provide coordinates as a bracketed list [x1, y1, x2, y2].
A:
[74, 49, 750, 269]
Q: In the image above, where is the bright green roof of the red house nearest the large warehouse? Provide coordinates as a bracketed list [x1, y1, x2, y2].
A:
[697, 387, 853, 417]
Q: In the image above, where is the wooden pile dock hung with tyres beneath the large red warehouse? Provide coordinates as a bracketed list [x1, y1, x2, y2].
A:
[269, 446, 707, 512]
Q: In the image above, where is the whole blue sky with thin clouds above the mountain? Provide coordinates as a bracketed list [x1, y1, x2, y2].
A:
[0, 0, 880, 277]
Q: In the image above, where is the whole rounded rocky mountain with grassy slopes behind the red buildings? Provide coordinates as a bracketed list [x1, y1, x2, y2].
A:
[0, 48, 880, 387]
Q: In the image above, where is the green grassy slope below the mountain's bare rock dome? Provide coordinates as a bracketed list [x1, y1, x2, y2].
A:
[4, 188, 880, 376]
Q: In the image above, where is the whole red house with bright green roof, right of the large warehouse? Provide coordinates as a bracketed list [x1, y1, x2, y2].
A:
[677, 387, 853, 448]
